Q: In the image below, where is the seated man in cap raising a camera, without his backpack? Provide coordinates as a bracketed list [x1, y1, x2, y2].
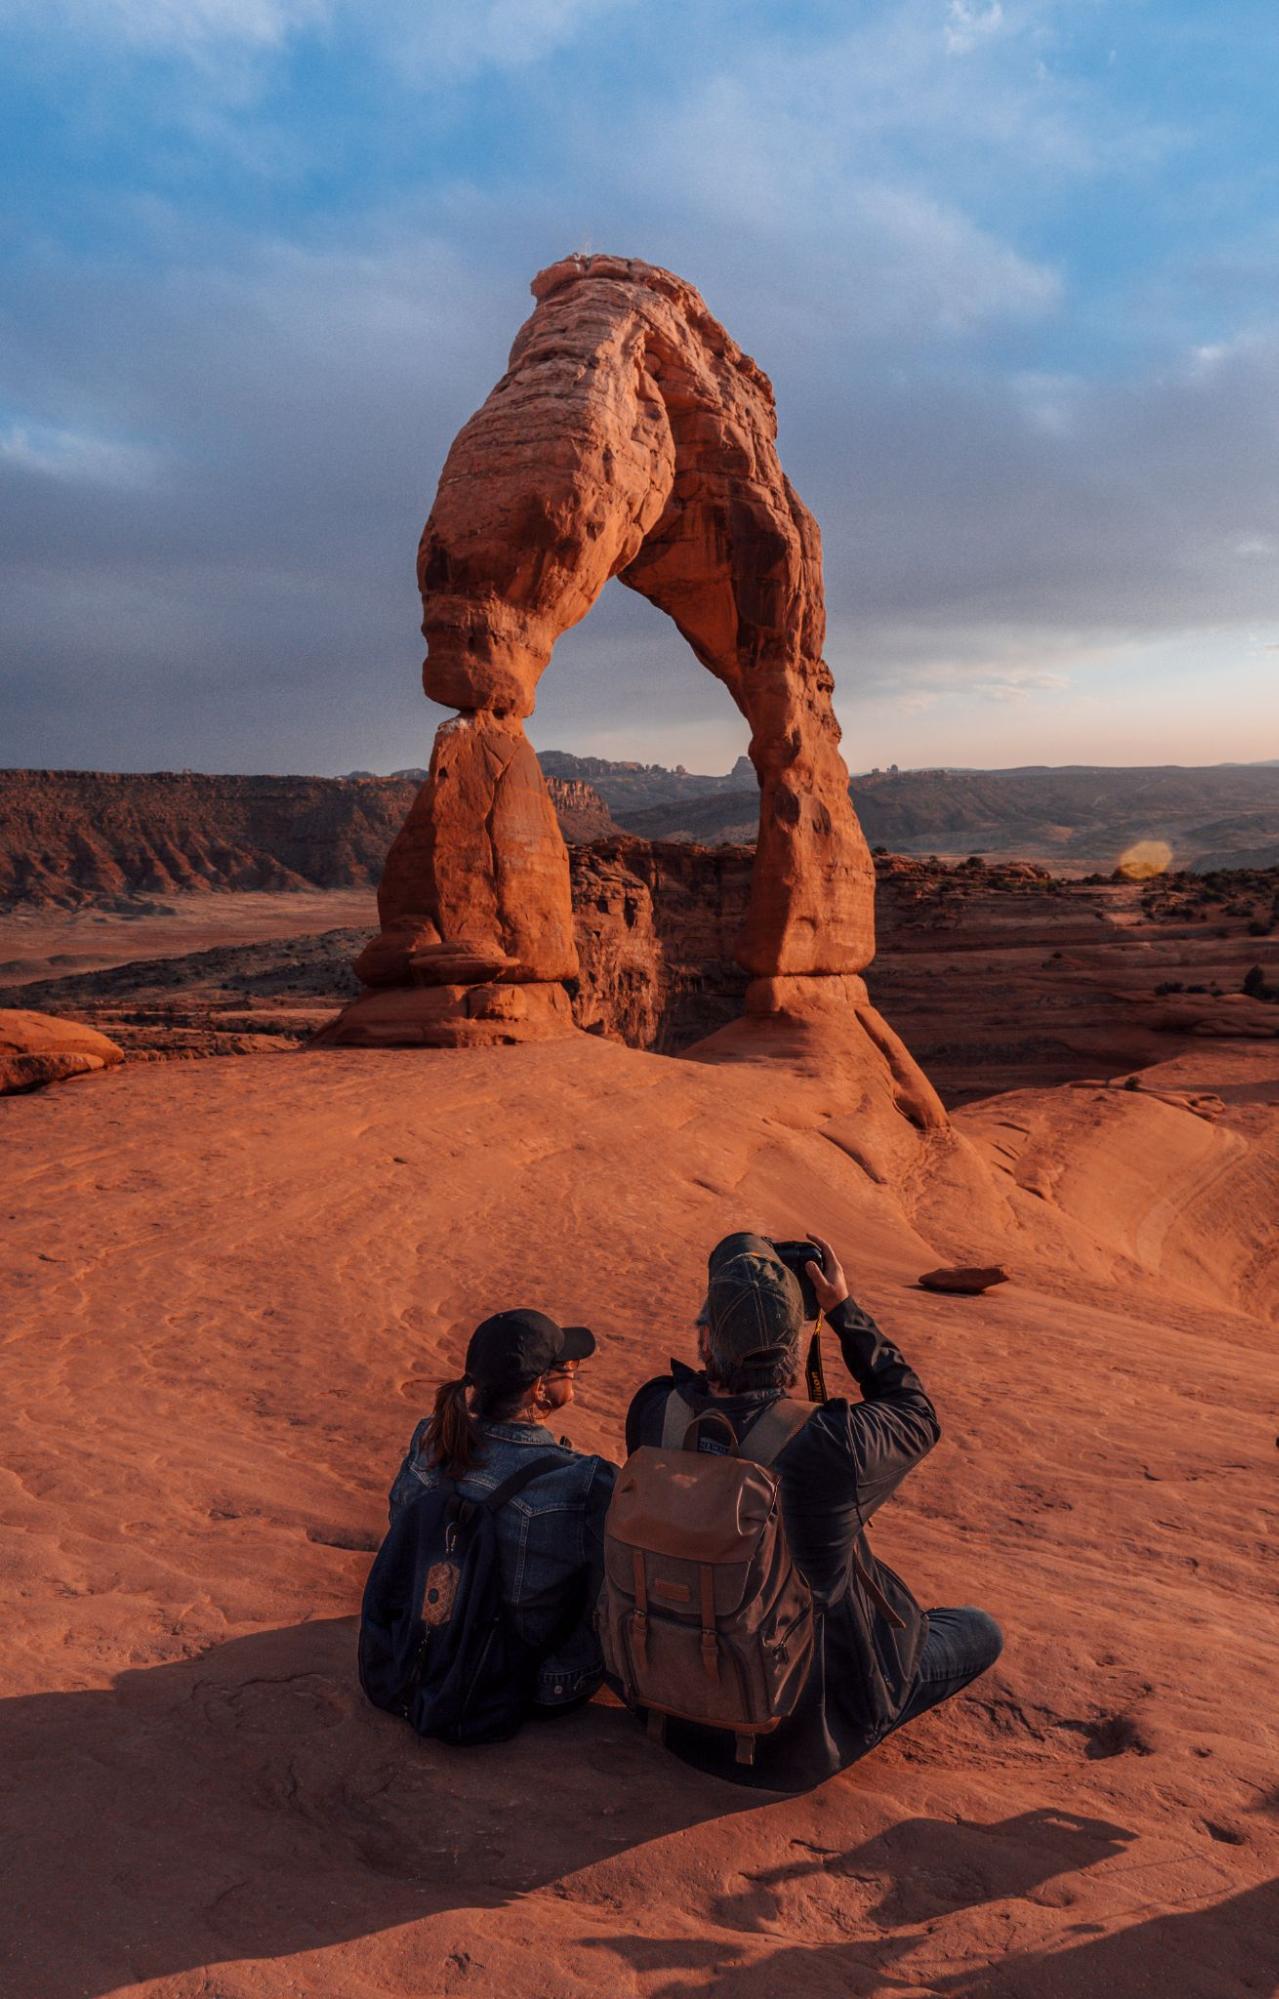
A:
[626, 1233, 1003, 1791]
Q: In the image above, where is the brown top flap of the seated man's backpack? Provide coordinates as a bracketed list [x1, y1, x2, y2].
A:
[608, 1443, 777, 1561]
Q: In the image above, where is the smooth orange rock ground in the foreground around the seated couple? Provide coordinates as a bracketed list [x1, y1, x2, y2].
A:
[0, 1037, 1279, 1999]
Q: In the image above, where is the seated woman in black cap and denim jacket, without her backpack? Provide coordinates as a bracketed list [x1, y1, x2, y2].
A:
[390, 1311, 618, 1715]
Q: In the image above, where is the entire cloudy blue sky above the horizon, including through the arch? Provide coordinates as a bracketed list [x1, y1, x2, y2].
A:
[0, 0, 1279, 772]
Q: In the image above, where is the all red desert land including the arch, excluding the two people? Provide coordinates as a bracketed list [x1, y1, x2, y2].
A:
[0, 256, 1279, 1999]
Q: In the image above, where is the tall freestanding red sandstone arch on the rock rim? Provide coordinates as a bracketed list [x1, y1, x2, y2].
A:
[330, 256, 873, 1043]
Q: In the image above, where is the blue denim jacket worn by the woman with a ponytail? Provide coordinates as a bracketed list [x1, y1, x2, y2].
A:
[390, 1419, 618, 1707]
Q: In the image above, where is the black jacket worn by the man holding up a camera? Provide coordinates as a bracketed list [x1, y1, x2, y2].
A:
[626, 1299, 941, 1791]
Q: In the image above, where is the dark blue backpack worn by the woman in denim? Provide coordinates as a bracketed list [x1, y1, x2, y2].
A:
[360, 1457, 563, 1743]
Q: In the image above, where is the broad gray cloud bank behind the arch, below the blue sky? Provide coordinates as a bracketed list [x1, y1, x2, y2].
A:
[0, 0, 1279, 770]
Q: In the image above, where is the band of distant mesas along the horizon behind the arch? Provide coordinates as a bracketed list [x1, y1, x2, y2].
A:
[0, 750, 1279, 914]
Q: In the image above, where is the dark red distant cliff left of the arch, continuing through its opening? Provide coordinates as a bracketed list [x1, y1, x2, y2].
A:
[0, 770, 616, 908]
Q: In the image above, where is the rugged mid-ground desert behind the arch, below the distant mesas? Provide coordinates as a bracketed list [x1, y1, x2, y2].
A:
[0, 803, 1279, 1105]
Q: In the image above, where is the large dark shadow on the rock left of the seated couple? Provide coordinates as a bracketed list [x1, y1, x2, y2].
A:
[0, 1619, 771, 1999]
